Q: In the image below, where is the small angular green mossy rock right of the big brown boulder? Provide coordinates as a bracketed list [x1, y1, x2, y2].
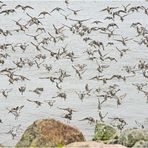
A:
[93, 123, 118, 142]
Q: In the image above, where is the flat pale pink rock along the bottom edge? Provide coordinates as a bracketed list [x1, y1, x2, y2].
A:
[63, 141, 126, 148]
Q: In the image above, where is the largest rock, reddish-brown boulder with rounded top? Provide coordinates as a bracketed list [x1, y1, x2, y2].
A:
[16, 119, 85, 147]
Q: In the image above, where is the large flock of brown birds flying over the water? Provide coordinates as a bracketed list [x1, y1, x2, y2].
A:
[0, 0, 148, 146]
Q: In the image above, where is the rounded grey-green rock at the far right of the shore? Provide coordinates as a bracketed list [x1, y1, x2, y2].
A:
[118, 129, 148, 147]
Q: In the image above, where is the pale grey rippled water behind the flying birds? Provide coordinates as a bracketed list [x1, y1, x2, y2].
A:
[0, 1, 148, 146]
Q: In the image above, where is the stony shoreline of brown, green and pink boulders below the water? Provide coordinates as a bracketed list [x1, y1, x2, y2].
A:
[0, 119, 148, 148]
